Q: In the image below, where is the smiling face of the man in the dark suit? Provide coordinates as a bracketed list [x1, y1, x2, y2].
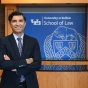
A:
[10, 15, 26, 33]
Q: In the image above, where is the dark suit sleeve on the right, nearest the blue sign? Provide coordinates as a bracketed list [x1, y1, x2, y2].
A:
[18, 40, 41, 75]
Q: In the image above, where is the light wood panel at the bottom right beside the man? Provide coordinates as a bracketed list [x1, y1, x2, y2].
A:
[37, 72, 88, 88]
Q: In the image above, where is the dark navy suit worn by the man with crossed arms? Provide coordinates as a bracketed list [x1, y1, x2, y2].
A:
[0, 34, 41, 88]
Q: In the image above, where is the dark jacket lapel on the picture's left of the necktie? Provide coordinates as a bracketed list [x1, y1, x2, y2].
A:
[9, 34, 20, 58]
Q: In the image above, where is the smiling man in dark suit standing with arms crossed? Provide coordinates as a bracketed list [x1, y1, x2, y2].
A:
[0, 11, 41, 88]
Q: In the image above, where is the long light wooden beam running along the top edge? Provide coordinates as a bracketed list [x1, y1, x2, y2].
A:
[1, 0, 88, 4]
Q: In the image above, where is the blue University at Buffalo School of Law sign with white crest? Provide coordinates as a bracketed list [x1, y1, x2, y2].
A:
[23, 12, 86, 69]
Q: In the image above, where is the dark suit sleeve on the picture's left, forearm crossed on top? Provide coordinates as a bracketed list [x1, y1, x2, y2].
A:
[0, 39, 27, 70]
